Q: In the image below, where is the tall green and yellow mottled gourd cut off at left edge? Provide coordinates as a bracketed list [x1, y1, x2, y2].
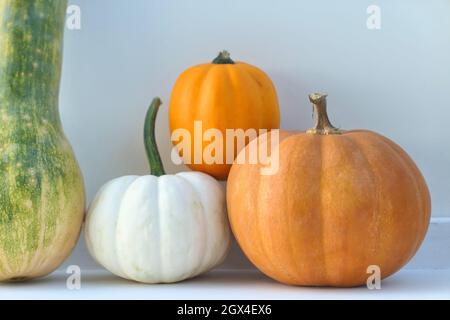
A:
[0, 0, 84, 281]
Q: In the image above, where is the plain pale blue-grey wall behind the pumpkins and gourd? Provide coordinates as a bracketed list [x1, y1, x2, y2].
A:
[60, 0, 450, 267]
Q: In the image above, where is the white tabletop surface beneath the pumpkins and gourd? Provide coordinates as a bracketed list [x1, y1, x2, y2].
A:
[0, 270, 450, 300]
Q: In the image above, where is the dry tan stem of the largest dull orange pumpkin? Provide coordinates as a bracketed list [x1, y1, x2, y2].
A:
[307, 93, 343, 135]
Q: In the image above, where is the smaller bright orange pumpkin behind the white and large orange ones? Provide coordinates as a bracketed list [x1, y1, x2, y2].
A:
[169, 51, 280, 180]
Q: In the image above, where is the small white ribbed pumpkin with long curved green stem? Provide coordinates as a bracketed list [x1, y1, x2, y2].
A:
[85, 99, 231, 283]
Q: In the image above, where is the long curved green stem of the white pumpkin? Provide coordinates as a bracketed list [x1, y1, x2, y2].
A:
[144, 98, 166, 177]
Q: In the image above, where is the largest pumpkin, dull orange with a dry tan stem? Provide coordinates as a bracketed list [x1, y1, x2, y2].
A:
[227, 94, 431, 287]
